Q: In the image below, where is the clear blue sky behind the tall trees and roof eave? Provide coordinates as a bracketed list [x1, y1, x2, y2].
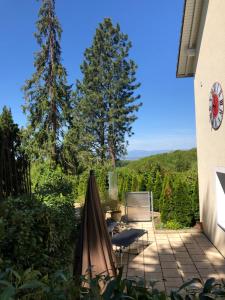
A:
[0, 0, 195, 150]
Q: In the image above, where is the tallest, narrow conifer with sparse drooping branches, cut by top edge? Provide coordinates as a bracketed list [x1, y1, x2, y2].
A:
[24, 0, 71, 162]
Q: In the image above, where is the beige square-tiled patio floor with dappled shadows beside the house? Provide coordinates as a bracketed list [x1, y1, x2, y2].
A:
[118, 222, 225, 292]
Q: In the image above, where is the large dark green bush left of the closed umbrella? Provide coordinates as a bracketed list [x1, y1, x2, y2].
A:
[0, 197, 75, 273]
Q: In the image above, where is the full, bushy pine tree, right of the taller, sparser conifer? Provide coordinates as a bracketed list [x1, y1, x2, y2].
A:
[74, 19, 141, 166]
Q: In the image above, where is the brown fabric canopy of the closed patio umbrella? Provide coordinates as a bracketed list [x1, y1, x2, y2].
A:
[74, 171, 116, 278]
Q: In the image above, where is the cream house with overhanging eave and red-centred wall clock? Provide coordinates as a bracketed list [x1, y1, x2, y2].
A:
[177, 0, 225, 256]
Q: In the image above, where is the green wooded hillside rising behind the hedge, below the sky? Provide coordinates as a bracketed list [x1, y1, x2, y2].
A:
[119, 148, 197, 172]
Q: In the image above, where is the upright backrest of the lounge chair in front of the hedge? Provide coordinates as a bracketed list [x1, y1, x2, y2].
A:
[125, 192, 151, 222]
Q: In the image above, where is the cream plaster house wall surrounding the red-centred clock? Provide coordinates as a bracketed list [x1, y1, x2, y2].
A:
[194, 0, 225, 256]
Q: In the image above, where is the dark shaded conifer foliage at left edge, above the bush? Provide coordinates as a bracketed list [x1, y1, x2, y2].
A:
[0, 106, 30, 200]
